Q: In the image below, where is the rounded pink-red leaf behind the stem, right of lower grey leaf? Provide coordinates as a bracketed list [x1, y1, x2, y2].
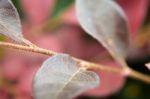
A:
[84, 59, 126, 97]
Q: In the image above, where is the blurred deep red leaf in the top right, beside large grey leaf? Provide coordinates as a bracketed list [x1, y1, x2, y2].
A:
[116, 0, 149, 33]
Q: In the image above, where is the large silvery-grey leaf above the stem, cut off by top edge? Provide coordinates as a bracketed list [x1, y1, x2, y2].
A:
[76, 0, 128, 66]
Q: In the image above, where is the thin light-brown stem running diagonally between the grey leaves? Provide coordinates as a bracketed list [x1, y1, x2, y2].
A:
[0, 42, 150, 84]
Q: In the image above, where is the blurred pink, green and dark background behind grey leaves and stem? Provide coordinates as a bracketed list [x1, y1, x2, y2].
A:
[0, 0, 150, 99]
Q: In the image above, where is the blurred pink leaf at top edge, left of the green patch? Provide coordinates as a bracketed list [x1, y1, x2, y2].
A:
[20, 0, 55, 27]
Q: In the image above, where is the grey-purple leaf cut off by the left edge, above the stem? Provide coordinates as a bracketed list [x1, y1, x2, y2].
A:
[0, 0, 24, 43]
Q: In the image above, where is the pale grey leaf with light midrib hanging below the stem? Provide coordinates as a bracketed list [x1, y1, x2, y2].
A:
[33, 54, 99, 99]
